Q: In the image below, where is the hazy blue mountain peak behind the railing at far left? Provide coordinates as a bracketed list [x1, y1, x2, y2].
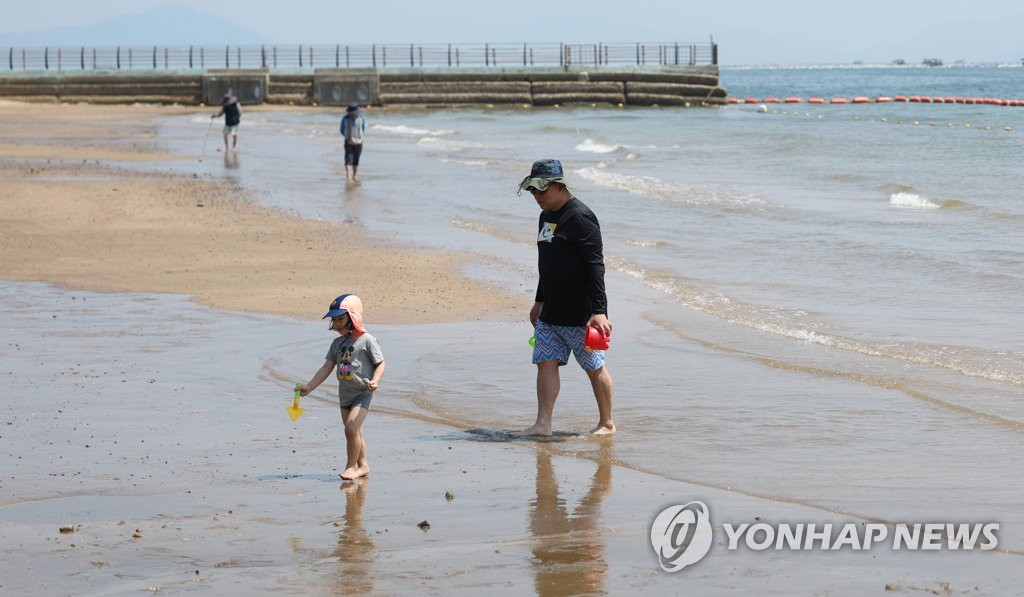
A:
[0, 6, 267, 46]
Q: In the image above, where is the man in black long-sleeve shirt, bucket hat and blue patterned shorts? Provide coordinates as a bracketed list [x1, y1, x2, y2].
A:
[519, 160, 615, 435]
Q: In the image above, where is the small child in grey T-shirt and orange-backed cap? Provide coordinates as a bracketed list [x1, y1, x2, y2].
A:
[299, 294, 384, 481]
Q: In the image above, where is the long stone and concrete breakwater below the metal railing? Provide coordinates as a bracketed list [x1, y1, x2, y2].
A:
[0, 66, 728, 108]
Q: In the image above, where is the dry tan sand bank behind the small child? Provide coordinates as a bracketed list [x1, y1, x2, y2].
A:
[0, 102, 522, 323]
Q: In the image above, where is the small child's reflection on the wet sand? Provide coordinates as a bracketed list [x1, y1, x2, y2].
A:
[331, 477, 377, 595]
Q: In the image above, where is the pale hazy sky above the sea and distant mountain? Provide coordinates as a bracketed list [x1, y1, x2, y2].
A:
[0, 0, 1024, 63]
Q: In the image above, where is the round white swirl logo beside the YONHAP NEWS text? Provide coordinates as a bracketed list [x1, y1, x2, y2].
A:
[650, 502, 713, 572]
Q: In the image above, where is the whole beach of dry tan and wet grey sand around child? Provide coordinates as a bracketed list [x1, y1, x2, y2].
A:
[0, 103, 1019, 595]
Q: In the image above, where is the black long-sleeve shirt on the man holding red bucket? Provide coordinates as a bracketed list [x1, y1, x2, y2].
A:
[537, 197, 608, 326]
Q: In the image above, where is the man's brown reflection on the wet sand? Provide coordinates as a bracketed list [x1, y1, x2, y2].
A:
[530, 445, 611, 595]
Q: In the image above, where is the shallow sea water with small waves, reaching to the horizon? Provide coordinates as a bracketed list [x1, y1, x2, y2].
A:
[151, 68, 1024, 549]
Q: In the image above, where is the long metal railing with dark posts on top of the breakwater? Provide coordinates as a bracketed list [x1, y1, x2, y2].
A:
[0, 40, 718, 73]
